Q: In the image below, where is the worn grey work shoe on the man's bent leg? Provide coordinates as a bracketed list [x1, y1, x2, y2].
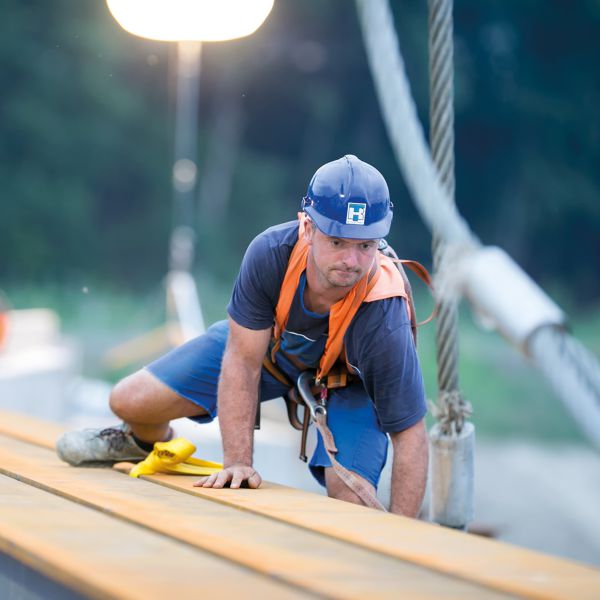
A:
[56, 423, 148, 466]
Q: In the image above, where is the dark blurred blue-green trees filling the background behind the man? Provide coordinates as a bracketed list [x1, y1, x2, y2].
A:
[0, 0, 600, 307]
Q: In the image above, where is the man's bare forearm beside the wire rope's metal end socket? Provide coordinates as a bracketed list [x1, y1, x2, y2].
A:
[390, 421, 429, 517]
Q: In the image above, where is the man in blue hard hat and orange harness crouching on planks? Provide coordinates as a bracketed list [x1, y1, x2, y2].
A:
[57, 155, 428, 517]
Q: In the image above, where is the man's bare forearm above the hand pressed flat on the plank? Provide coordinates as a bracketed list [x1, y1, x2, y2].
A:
[218, 351, 260, 467]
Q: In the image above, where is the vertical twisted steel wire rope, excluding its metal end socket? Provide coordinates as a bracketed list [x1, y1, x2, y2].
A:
[429, 0, 472, 435]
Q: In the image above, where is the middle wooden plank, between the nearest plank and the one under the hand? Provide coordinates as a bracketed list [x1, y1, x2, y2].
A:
[0, 436, 505, 598]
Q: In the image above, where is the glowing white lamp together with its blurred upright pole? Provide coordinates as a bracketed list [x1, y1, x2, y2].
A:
[106, 0, 274, 341]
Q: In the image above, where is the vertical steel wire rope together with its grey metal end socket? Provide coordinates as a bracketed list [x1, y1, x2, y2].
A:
[429, 0, 475, 529]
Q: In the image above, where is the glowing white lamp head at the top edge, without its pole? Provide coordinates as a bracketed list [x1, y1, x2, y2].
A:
[107, 0, 274, 42]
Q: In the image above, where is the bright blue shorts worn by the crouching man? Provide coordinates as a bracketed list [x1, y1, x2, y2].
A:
[146, 321, 388, 487]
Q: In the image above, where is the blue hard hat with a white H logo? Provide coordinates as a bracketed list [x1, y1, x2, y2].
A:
[302, 154, 393, 240]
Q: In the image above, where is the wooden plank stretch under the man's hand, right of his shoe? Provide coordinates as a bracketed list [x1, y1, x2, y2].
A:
[132, 463, 600, 600]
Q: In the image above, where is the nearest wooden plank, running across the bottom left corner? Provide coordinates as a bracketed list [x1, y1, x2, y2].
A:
[0, 475, 307, 600]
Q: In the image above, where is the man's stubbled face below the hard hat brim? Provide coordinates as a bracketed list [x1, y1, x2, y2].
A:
[304, 219, 379, 288]
